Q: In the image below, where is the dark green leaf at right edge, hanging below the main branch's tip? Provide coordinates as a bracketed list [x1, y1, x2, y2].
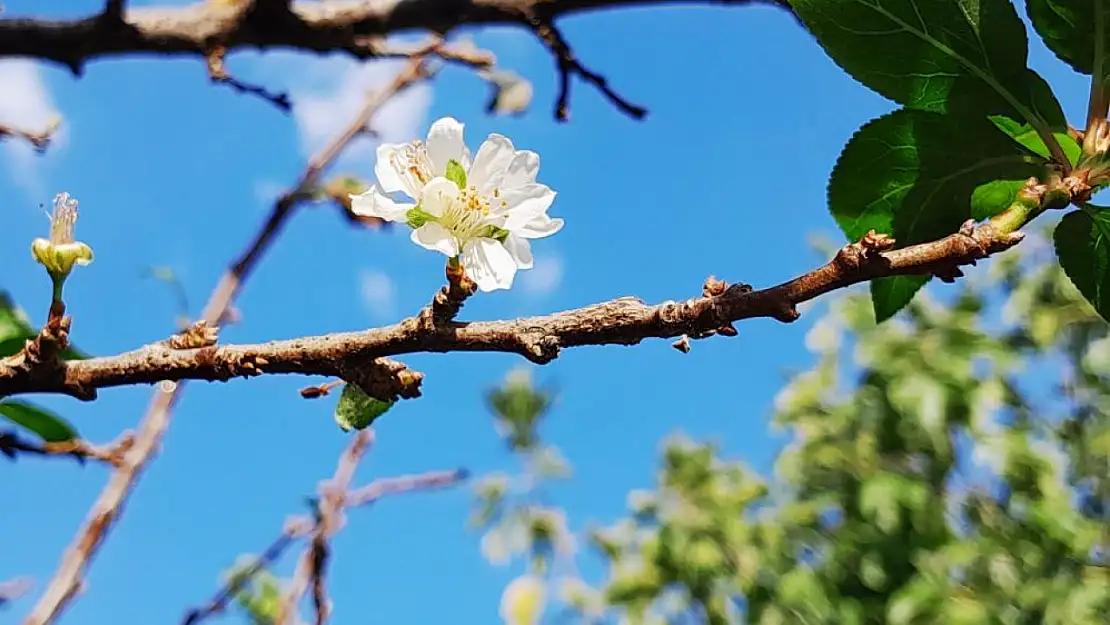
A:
[1052, 206, 1110, 320]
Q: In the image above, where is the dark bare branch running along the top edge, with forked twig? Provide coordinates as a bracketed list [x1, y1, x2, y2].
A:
[0, 0, 789, 119]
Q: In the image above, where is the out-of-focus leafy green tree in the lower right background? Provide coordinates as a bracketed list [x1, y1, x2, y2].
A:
[501, 233, 1110, 625]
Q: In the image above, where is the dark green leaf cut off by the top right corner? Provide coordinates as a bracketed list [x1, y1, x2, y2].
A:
[1026, 0, 1110, 75]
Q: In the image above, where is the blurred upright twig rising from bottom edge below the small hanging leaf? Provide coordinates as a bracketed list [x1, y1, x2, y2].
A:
[274, 429, 374, 625]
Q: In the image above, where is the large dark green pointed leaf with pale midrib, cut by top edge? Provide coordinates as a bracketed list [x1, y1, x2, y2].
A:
[790, 0, 1063, 130]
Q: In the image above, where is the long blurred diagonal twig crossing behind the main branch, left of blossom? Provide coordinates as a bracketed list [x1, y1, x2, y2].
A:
[18, 54, 427, 625]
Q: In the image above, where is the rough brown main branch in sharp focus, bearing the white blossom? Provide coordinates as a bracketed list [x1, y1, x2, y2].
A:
[0, 222, 1021, 399]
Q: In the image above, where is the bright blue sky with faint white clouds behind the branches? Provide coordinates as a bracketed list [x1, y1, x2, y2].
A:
[0, 0, 1086, 625]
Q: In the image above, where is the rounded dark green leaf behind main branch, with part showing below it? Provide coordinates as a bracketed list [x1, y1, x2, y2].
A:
[828, 109, 1040, 322]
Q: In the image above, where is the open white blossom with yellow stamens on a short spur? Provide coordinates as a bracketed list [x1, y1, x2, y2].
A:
[351, 118, 563, 291]
